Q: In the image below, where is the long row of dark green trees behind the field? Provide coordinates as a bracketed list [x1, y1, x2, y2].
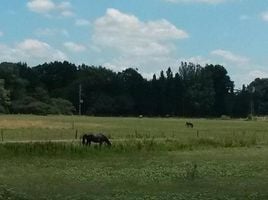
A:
[0, 61, 268, 117]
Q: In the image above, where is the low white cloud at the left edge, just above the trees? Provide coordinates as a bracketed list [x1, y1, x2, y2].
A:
[0, 39, 67, 65]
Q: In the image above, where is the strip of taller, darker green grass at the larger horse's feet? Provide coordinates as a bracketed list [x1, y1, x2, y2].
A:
[0, 135, 256, 156]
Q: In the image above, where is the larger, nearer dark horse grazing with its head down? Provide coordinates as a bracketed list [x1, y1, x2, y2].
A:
[82, 133, 112, 147]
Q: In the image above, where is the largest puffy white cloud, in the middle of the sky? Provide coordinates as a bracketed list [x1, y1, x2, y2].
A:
[92, 8, 188, 70]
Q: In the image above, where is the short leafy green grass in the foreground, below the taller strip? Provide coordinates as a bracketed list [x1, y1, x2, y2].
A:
[0, 148, 268, 199]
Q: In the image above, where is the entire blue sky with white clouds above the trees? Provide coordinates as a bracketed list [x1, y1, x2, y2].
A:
[0, 0, 268, 88]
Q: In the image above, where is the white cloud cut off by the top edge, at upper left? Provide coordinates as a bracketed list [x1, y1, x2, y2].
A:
[27, 0, 74, 17]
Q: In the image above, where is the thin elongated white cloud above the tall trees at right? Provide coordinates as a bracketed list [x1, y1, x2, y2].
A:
[211, 49, 249, 65]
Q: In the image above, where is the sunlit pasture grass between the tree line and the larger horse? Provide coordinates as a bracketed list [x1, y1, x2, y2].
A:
[0, 115, 268, 144]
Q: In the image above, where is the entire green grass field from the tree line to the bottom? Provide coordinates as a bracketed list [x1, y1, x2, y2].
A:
[0, 115, 268, 200]
